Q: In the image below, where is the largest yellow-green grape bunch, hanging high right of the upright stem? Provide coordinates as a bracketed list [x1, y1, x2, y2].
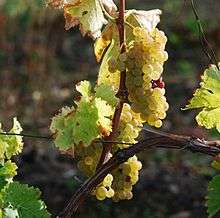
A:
[108, 27, 169, 128]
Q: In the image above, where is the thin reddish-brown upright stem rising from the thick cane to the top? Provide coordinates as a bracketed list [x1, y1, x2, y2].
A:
[97, 0, 128, 169]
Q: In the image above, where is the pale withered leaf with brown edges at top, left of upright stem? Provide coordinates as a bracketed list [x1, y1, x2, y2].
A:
[64, 0, 107, 38]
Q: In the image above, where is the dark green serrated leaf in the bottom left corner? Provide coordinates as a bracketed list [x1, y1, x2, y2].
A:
[3, 182, 51, 218]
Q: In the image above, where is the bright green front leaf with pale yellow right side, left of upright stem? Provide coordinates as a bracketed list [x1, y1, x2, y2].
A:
[73, 81, 115, 146]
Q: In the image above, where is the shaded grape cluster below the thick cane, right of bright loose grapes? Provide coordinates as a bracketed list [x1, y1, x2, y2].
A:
[112, 156, 142, 202]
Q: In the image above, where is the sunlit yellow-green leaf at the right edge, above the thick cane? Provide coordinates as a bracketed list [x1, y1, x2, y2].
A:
[185, 65, 220, 132]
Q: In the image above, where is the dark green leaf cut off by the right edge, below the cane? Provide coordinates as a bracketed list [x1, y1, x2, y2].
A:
[206, 175, 220, 217]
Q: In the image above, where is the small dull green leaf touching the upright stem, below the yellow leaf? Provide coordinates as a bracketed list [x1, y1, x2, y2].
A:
[95, 84, 118, 107]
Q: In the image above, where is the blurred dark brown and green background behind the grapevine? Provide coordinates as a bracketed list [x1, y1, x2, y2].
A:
[0, 0, 220, 218]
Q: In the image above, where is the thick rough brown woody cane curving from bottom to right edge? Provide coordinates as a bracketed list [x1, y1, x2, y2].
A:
[58, 129, 220, 218]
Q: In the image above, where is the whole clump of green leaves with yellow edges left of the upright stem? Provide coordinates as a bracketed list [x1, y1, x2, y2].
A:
[50, 81, 115, 150]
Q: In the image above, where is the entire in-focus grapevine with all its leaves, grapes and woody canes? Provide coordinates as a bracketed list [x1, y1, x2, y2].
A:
[0, 0, 220, 218]
